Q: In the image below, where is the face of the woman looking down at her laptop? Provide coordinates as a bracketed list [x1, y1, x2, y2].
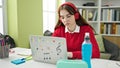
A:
[60, 9, 76, 28]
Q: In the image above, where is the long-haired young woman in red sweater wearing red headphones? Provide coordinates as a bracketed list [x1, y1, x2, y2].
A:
[52, 2, 100, 59]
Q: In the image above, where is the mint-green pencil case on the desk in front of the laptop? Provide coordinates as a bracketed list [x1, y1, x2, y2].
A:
[57, 60, 88, 68]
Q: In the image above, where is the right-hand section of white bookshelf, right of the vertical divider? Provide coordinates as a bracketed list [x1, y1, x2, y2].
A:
[100, 0, 120, 35]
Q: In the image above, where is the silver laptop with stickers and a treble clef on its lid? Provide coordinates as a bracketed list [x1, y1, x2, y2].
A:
[29, 35, 67, 64]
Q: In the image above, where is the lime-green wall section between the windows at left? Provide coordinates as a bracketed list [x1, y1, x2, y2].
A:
[7, 0, 43, 48]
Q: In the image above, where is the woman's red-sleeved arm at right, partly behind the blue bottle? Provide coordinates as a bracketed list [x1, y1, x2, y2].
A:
[71, 27, 100, 59]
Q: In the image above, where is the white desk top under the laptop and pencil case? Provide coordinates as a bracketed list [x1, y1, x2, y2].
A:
[0, 48, 120, 68]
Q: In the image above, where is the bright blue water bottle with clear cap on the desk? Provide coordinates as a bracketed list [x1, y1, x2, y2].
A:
[82, 32, 92, 68]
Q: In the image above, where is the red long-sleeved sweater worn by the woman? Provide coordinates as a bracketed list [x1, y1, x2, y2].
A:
[52, 26, 100, 59]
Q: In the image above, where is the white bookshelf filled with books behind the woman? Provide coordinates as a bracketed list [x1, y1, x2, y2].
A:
[62, 0, 120, 35]
